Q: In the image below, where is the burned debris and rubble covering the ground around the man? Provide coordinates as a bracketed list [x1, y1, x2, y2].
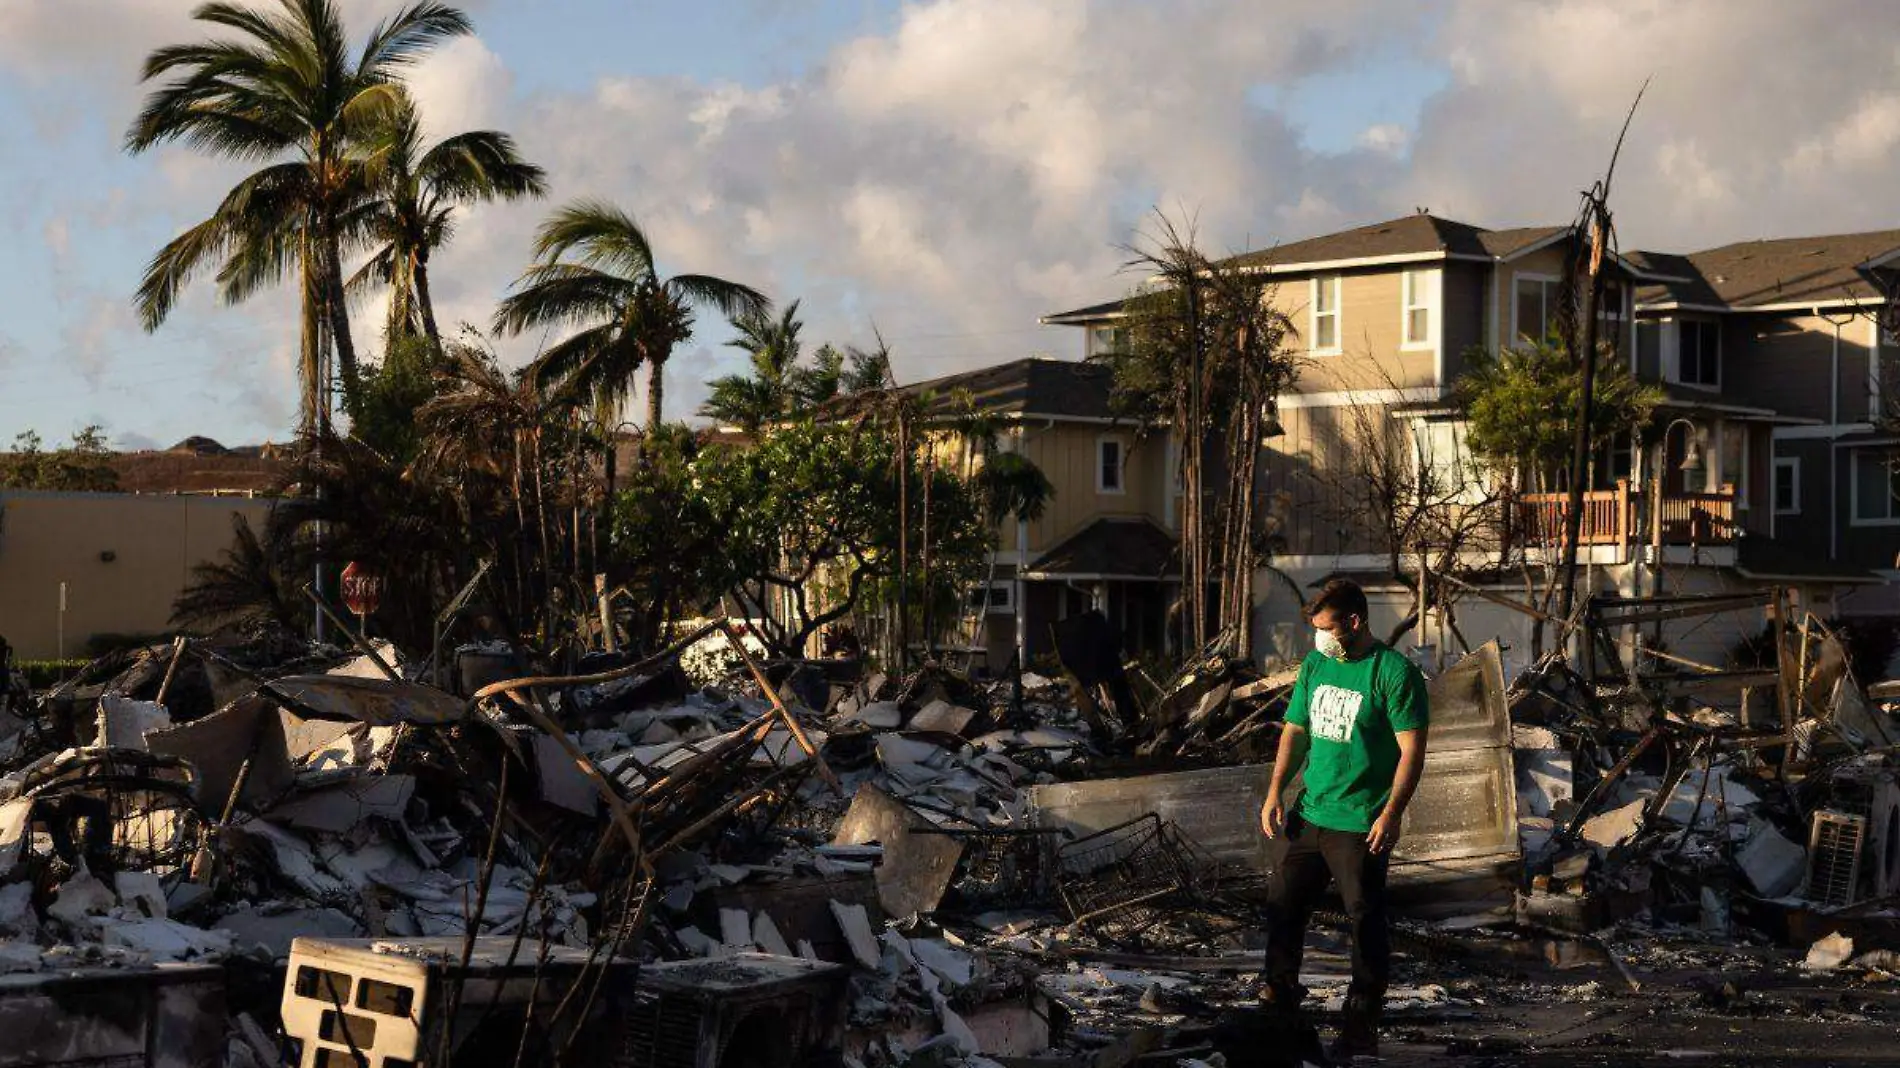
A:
[0, 599, 1900, 1068]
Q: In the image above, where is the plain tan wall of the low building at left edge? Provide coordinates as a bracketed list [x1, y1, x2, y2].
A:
[0, 492, 272, 659]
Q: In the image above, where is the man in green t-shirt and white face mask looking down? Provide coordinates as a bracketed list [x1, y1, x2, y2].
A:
[1260, 580, 1431, 1060]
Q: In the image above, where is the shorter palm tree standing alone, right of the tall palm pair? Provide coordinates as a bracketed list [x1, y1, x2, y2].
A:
[494, 200, 771, 433]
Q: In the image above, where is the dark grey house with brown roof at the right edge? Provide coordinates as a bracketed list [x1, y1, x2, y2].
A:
[1632, 230, 1900, 589]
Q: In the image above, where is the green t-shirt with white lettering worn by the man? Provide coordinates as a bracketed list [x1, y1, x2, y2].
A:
[1286, 642, 1431, 832]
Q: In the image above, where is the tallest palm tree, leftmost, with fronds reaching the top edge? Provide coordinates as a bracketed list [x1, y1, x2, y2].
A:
[125, 0, 471, 431]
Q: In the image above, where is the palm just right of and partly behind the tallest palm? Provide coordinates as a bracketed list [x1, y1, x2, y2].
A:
[350, 91, 547, 346]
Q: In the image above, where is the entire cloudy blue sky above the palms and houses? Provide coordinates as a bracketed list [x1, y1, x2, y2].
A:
[0, 0, 1900, 448]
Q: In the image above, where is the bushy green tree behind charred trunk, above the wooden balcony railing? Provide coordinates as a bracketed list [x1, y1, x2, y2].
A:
[1457, 342, 1663, 490]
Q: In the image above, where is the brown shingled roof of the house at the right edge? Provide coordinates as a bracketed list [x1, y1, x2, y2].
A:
[1632, 230, 1900, 310]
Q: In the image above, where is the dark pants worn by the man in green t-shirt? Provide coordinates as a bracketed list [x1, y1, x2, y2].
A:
[1262, 813, 1393, 1017]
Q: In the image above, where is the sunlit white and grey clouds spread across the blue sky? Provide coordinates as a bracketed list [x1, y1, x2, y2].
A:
[18, 0, 1900, 435]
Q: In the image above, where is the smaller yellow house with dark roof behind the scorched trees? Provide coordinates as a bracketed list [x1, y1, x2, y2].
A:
[881, 357, 1180, 669]
